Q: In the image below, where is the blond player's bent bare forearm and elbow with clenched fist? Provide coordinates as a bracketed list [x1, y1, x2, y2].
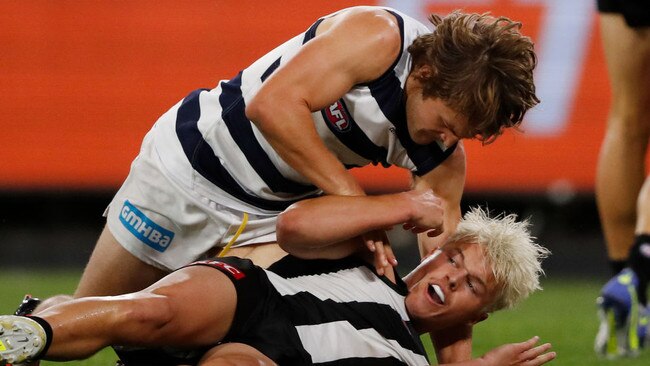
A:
[277, 190, 442, 259]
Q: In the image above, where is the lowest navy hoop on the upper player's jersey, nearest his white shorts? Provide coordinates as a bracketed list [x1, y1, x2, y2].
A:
[176, 89, 310, 211]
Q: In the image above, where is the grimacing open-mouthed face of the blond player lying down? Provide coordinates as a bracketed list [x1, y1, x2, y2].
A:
[405, 244, 497, 332]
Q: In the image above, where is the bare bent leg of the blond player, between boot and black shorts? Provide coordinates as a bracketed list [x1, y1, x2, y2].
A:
[33, 266, 237, 360]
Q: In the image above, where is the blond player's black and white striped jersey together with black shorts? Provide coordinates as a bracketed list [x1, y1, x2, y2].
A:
[114, 255, 429, 366]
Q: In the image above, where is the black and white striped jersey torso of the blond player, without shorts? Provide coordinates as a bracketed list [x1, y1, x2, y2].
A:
[266, 256, 429, 366]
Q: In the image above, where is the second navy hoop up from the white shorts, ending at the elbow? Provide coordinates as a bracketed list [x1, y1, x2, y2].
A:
[219, 72, 316, 194]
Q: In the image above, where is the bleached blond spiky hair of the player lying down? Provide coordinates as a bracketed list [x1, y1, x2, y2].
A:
[445, 207, 550, 312]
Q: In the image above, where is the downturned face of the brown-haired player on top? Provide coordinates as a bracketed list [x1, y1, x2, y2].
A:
[406, 69, 474, 148]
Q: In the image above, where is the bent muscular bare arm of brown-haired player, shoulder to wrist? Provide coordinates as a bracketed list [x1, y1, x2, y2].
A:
[246, 8, 401, 195]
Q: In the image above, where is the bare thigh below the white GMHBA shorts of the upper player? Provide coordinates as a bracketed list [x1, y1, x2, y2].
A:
[74, 227, 168, 298]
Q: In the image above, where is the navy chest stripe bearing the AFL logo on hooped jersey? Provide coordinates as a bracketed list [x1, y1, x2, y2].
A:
[321, 99, 390, 167]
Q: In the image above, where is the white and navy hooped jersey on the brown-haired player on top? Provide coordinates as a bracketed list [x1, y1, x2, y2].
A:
[154, 8, 453, 214]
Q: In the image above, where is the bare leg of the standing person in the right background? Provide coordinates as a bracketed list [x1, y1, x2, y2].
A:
[596, 13, 650, 261]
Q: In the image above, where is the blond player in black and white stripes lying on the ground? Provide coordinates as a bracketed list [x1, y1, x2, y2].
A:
[0, 192, 555, 365]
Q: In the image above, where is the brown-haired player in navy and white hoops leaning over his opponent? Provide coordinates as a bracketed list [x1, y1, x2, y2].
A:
[69, 7, 538, 314]
